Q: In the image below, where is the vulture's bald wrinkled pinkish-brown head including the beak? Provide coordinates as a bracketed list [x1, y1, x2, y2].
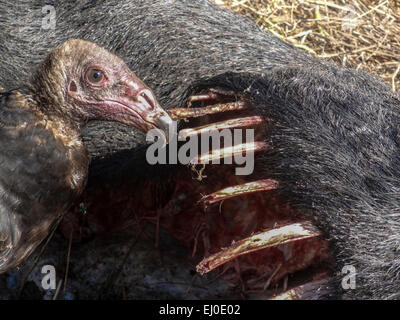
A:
[32, 40, 172, 137]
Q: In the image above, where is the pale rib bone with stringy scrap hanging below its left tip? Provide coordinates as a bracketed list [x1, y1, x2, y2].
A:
[190, 142, 268, 164]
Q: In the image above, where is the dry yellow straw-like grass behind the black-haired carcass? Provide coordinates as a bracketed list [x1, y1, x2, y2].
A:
[214, 0, 400, 90]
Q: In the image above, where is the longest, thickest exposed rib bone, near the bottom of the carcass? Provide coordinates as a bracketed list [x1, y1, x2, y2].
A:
[196, 222, 320, 274]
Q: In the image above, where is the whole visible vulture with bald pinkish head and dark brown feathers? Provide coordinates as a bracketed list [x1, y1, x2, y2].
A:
[0, 40, 171, 272]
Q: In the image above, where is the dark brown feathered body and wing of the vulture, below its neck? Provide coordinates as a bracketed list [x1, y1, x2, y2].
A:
[0, 91, 88, 273]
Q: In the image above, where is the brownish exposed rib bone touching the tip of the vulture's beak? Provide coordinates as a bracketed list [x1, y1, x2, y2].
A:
[167, 101, 246, 120]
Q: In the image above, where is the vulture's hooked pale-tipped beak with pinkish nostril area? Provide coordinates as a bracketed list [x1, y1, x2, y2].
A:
[114, 76, 174, 143]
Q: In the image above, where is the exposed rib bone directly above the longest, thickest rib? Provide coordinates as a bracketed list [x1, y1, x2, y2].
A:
[201, 179, 278, 205]
